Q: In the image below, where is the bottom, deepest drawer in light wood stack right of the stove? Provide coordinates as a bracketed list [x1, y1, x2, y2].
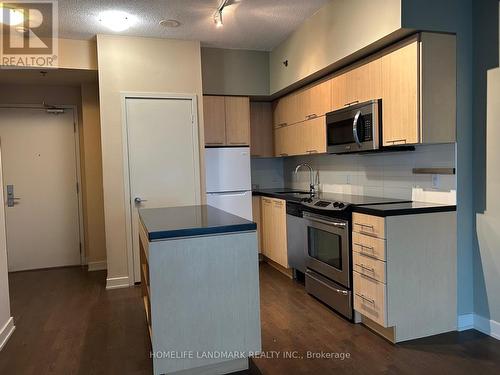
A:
[353, 271, 387, 327]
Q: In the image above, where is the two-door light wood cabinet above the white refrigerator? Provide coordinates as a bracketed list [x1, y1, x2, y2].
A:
[203, 95, 250, 146]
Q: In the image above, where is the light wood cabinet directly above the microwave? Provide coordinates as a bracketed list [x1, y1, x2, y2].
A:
[331, 58, 382, 110]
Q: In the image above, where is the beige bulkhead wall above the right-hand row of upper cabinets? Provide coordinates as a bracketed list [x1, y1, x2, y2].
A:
[269, 0, 402, 94]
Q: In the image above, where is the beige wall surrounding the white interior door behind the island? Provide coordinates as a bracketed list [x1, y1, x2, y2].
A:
[97, 35, 205, 286]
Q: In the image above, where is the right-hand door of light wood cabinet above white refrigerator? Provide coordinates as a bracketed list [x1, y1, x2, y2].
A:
[225, 96, 250, 146]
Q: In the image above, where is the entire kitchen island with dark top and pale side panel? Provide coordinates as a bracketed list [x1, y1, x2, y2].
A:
[139, 205, 261, 374]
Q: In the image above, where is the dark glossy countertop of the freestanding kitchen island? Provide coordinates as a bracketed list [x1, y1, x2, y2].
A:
[139, 205, 257, 241]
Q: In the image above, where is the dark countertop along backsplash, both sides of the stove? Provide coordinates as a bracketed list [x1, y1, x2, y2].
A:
[252, 188, 457, 217]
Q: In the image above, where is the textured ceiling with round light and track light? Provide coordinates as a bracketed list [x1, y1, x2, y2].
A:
[59, 0, 330, 51]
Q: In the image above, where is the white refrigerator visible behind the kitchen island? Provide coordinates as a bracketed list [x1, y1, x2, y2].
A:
[205, 147, 252, 220]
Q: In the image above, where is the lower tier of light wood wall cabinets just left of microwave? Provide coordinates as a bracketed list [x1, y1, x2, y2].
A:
[274, 116, 326, 156]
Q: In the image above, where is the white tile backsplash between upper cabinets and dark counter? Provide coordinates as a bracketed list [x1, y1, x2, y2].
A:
[252, 144, 456, 204]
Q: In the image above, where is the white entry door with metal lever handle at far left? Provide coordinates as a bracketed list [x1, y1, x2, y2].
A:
[0, 108, 81, 271]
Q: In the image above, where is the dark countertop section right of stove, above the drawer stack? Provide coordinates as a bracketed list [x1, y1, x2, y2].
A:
[354, 202, 457, 217]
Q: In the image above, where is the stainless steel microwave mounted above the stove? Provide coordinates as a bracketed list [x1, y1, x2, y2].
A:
[326, 99, 382, 154]
